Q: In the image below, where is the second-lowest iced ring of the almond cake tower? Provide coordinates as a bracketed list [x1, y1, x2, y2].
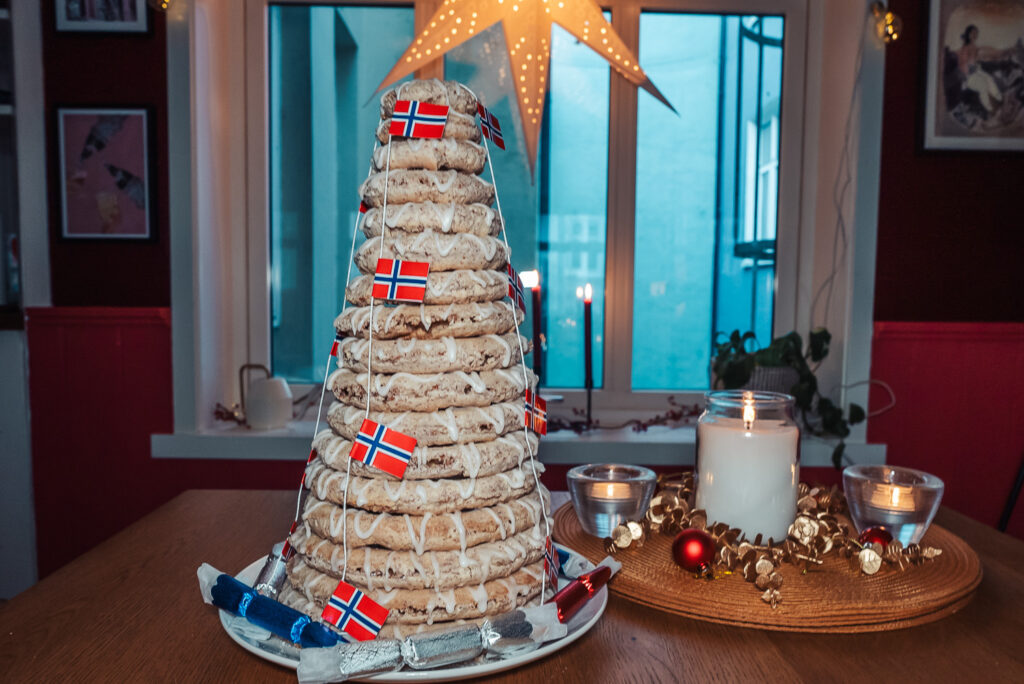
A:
[288, 556, 544, 624]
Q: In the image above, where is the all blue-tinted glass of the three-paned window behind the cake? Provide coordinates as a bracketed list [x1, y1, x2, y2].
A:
[269, 6, 784, 401]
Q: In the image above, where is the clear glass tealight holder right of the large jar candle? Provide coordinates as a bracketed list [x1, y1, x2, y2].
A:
[843, 466, 945, 546]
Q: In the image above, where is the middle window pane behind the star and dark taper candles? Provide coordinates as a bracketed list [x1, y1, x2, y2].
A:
[444, 22, 610, 388]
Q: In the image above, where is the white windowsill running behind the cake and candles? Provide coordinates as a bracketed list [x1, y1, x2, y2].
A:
[151, 421, 886, 467]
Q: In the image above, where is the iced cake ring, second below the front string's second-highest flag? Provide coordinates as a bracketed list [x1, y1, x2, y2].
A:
[338, 333, 530, 373]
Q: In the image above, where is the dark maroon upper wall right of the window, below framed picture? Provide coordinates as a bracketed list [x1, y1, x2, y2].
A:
[874, 0, 1024, 322]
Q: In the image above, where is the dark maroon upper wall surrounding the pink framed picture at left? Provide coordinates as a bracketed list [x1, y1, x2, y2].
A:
[39, 0, 171, 306]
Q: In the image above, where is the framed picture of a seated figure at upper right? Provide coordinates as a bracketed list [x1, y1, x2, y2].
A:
[924, 0, 1024, 151]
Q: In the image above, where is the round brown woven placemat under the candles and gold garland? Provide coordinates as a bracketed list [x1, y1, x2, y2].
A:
[553, 504, 981, 633]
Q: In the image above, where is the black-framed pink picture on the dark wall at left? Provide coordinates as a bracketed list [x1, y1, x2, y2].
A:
[57, 108, 154, 240]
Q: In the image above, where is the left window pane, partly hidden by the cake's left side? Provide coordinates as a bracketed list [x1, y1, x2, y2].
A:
[268, 5, 413, 382]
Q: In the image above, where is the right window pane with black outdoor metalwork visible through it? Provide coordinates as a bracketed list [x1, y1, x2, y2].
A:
[632, 12, 782, 390]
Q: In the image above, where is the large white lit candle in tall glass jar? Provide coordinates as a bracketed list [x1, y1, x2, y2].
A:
[695, 390, 800, 542]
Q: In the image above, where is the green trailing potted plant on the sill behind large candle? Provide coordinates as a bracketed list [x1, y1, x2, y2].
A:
[712, 328, 866, 469]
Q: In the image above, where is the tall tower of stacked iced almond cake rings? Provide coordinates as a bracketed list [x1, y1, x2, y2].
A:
[281, 80, 550, 637]
